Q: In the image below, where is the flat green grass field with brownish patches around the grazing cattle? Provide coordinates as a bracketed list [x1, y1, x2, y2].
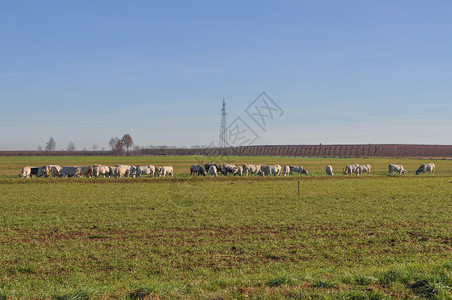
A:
[0, 157, 452, 299]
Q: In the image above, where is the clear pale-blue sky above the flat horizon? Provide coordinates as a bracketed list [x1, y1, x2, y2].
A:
[0, 0, 452, 150]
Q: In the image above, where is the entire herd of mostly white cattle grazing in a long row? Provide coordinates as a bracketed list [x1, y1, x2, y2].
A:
[19, 163, 436, 178]
